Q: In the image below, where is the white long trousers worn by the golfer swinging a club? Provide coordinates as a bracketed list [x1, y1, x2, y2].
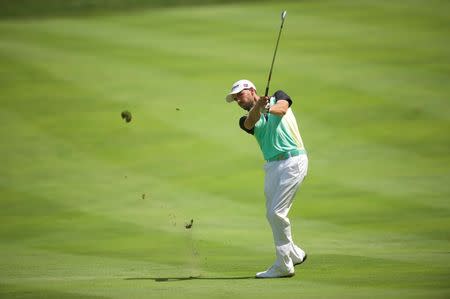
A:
[264, 155, 308, 270]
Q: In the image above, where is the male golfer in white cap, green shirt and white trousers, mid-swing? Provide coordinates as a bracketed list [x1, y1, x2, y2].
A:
[226, 80, 308, 278]
